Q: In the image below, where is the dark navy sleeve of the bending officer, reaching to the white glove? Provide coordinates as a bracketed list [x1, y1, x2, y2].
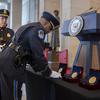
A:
[28, 29, 51, 76]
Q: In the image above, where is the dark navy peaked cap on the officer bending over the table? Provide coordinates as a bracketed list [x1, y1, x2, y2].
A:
[42, 11, 60, 29]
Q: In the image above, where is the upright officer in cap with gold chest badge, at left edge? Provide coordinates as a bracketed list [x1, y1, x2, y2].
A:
[0, 9, 14, 50]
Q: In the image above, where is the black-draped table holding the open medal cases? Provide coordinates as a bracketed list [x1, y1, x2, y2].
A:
[26, 72, 100, 100]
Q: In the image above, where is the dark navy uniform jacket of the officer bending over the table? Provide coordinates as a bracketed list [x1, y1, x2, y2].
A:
[14, 23, 51, 76]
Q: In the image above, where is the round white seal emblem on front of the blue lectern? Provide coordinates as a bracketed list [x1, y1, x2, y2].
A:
[68, 16, 83, 36]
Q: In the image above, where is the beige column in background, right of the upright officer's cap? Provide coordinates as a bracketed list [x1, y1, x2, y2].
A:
[10, 0, 22, 30]
